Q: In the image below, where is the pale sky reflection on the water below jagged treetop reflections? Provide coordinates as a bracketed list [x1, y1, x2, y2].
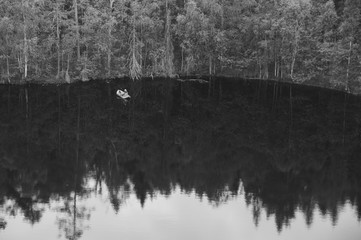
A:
[0, 181, 361, 240]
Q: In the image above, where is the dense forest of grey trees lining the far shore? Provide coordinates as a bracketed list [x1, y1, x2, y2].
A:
[0, 0, 361, 90]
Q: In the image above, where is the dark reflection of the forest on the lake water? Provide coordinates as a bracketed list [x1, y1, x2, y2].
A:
[0, 81, 361, 232]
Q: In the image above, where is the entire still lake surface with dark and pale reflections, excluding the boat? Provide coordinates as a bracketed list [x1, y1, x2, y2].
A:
[0, 80, 361, 240]
